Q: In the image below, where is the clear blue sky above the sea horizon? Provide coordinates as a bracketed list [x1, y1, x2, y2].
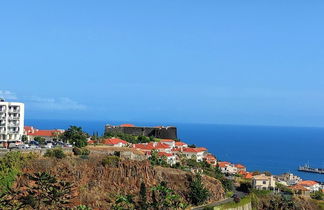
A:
[0, 0, 324, 126]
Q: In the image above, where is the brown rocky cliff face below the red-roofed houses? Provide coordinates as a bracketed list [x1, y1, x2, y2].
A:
[20, 156, 224, 209]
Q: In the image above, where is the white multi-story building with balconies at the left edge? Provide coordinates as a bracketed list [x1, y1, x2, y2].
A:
[0, 99, 24, 145]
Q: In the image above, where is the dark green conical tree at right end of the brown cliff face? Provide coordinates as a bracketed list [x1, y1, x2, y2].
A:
[189, 175, 210, 205]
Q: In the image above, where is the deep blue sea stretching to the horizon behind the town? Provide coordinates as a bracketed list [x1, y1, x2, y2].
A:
[26, 120, 324, 182]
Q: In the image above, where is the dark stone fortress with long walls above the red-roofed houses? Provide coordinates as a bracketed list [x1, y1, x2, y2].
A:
[105, 124, 177, 139]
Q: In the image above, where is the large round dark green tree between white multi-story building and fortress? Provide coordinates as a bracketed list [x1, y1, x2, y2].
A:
[60, 126, 88, 147]
